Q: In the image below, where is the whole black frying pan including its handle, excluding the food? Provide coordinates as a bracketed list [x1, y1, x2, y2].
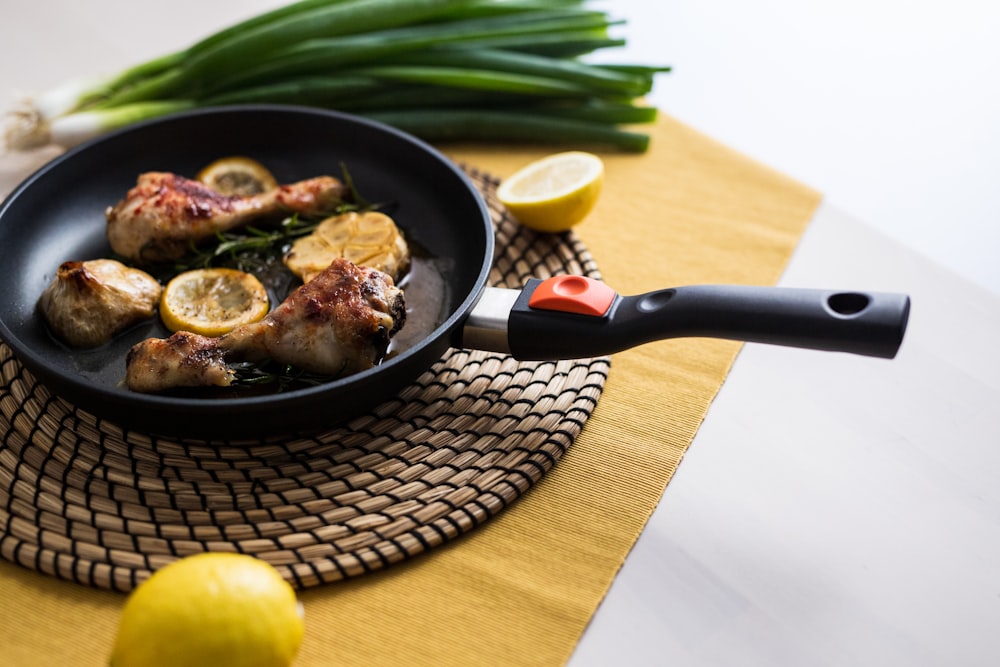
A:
[0, 105, 909, 438]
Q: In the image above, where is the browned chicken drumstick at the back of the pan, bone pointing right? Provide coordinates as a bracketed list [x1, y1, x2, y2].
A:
[105, 172, 350, 263]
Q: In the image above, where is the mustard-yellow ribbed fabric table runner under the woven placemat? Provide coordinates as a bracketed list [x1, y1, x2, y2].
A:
[0, 117, 820, 667]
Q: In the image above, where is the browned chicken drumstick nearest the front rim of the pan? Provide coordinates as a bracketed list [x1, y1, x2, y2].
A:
[126, 259, 406, 393]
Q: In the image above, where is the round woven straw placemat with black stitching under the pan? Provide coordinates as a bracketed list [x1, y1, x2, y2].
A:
[0, 168, 609, 591]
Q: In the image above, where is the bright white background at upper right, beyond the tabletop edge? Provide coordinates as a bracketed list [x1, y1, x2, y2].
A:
[600, 0, 1000, 293]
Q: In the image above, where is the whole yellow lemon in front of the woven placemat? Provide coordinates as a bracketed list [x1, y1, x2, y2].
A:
[109, 553, 305, 667]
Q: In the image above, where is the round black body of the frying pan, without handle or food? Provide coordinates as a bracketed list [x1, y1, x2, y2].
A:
[0, 106, 493, 430]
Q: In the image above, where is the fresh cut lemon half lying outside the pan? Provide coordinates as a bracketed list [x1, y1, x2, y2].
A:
[497, 151, 604, 232]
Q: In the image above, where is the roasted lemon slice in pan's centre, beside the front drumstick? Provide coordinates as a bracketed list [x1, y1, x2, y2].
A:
[160, 269, 269, 336]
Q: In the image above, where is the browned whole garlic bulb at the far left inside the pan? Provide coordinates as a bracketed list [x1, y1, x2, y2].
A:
[38, 259, 163, 348]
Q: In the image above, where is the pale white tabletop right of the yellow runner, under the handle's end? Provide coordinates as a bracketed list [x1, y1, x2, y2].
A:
[572, 205, 1000, 667]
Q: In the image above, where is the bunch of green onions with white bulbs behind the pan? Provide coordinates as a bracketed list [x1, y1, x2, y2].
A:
[4, 0, 669, 151]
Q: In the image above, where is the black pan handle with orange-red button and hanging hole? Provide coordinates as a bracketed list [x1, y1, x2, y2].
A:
[476, 276, 910, 360]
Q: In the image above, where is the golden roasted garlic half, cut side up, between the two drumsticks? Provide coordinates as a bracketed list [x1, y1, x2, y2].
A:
[285, 211, 410, 282]
